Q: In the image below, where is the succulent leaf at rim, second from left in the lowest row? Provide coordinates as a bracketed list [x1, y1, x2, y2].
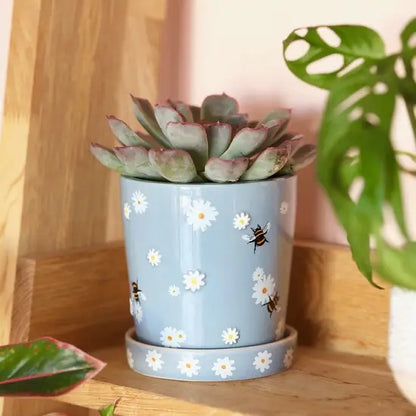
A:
[114, 146, 166, 179]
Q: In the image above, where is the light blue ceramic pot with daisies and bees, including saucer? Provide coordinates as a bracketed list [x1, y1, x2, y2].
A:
[121, 177, 296, 380]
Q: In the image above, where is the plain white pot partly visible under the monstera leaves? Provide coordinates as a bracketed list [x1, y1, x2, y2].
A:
[388, 287, 416, 405]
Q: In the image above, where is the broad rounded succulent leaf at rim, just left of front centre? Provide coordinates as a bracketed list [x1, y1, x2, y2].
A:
[149, 149, 198, 183]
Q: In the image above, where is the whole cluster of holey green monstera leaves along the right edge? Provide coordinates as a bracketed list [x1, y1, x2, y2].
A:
[283, 19, 416, 289]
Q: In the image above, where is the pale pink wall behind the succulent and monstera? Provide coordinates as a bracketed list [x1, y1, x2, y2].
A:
[160, 0, 416, 244]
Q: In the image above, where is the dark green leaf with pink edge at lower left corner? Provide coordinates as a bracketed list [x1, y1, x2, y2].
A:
[0, 337, 105, 396]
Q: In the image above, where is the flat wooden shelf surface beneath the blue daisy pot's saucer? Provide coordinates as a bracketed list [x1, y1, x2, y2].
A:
[59, 346, 415, 416]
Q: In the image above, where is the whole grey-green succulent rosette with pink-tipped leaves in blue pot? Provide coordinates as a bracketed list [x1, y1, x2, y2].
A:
[91, 94, 315, 183]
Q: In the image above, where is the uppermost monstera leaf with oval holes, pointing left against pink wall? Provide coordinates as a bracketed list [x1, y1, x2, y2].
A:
[283, 25, 385, 89]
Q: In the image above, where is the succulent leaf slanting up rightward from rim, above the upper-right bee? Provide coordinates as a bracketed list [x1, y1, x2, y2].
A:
[241, 145, 290, 181]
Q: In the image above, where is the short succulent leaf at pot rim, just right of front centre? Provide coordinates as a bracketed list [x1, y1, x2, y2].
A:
[204, 157, 248, 183]
